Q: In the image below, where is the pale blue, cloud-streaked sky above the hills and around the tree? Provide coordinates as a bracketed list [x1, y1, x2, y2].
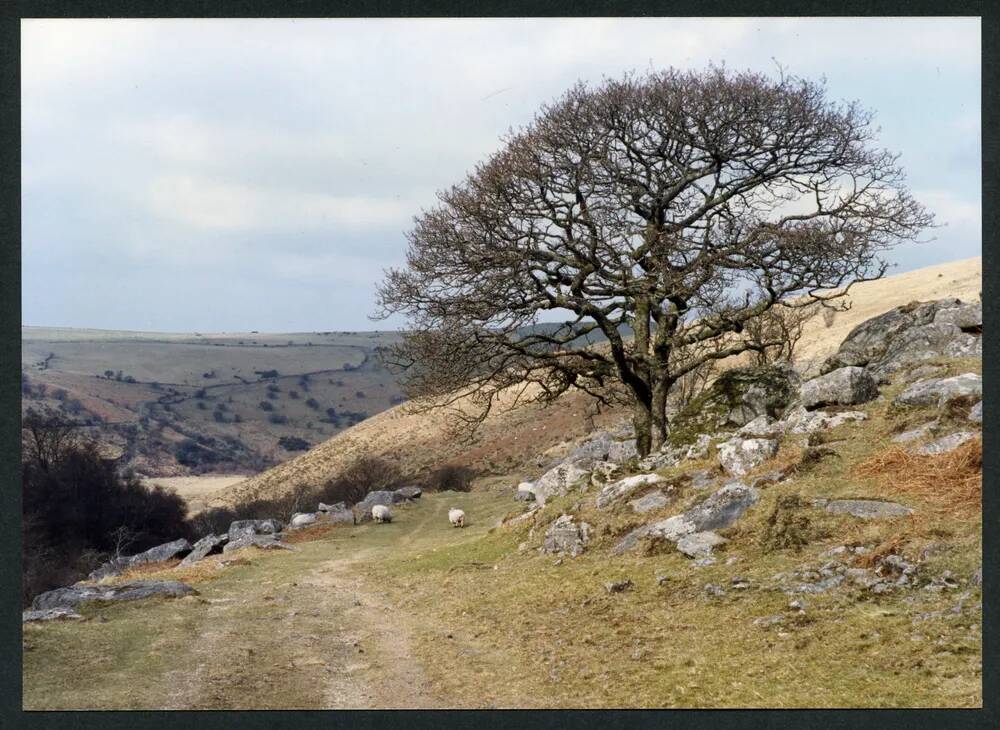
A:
[21, 18, 982, 332]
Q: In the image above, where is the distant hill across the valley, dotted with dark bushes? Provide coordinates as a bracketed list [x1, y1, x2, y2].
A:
[21, 327, 403, 476]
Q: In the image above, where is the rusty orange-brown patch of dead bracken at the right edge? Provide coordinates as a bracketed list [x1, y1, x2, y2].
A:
[854, 437, 983, 516]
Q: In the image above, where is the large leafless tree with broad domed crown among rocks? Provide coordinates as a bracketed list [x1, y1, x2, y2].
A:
[377, 68, 933, 454]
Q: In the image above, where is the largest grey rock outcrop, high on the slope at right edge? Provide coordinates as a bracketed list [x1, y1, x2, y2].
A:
[821, 299, 983, 381]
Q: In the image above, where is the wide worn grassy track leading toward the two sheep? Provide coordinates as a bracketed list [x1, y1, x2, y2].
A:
[24, 494, 507, 709]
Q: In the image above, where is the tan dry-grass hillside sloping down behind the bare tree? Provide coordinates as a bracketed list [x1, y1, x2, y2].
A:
[218, 257, 982, 504]
